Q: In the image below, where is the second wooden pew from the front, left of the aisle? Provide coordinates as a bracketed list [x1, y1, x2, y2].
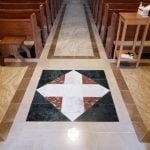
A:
[0, 5, 48, 45]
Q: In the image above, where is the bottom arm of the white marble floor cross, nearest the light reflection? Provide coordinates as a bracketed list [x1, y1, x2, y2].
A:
[61, 97, 84, 121]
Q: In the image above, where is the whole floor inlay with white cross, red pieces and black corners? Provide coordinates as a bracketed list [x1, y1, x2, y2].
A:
[27, 70, 118, 122]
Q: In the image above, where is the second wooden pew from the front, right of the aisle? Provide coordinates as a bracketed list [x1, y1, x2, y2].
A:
[100, 3, 139, 43]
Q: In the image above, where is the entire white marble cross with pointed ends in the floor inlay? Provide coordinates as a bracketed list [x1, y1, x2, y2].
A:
[37, 71, 109, 121]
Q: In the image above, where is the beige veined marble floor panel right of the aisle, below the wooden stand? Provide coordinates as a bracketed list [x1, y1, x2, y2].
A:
[121, 66, 150, 130]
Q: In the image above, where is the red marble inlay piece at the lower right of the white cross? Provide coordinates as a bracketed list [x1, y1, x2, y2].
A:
[83, 97, 100, 110]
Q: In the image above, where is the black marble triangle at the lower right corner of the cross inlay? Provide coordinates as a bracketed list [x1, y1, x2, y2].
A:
[76, 92, 119, 122]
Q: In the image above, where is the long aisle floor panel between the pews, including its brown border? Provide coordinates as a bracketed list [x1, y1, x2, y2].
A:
[48, 3, 100, 59]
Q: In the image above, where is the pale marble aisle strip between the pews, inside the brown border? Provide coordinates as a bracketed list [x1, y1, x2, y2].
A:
[54, 4, 93, 56]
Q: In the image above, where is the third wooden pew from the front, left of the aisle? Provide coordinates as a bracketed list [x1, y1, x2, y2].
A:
[0, 0, 52, 32]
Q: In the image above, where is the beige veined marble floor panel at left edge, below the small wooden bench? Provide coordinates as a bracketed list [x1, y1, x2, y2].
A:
[0, 67, 27, 122]
